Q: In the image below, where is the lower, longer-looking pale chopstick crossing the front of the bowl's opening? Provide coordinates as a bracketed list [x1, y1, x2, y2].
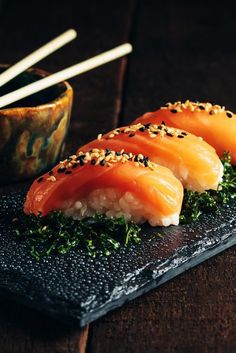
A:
[0, 43, 132, 108]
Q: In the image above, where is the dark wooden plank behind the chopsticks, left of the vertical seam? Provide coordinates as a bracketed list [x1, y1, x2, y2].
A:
[0, 0, 135, 151]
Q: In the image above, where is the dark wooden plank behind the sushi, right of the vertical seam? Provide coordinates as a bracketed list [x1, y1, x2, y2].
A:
[121, 0, 236, 123]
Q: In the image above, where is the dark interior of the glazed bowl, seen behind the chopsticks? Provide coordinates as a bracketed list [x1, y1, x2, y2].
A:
[0, 66, 67, 108]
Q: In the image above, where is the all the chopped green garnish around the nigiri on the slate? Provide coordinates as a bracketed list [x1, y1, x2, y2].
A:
[13, 153, 236, 260]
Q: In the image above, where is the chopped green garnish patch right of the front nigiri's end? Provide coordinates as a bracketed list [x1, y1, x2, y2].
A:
[180, 153, 236, 224]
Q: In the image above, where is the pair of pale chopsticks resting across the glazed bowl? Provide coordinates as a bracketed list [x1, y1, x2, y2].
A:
[0, 29, 132, 108]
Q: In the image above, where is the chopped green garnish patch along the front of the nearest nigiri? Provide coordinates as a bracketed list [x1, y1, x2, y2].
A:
[16, 212, 141, 260]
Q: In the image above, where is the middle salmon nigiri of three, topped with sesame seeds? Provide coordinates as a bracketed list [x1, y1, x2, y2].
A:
[82, 123, 223, 192]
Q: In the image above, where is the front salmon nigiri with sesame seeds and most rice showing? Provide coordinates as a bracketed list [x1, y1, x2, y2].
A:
[24, 149, 183, 226]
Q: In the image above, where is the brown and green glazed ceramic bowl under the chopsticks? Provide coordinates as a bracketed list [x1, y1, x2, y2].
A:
[0, 65, 73, 184]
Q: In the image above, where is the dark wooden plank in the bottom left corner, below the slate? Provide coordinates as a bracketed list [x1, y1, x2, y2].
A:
[0, 298, 88, 353]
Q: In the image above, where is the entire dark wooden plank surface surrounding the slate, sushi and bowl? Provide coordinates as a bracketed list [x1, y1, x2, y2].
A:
[0, 0, 236, 353]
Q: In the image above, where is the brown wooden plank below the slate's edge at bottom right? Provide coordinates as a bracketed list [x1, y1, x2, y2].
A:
[88, 248, 236, 353]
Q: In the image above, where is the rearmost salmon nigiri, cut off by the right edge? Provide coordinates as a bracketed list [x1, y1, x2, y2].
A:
[133, 100, 236, 165]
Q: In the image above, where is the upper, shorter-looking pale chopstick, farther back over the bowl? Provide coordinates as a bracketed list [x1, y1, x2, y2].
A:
[0, 29, 77, 87]
